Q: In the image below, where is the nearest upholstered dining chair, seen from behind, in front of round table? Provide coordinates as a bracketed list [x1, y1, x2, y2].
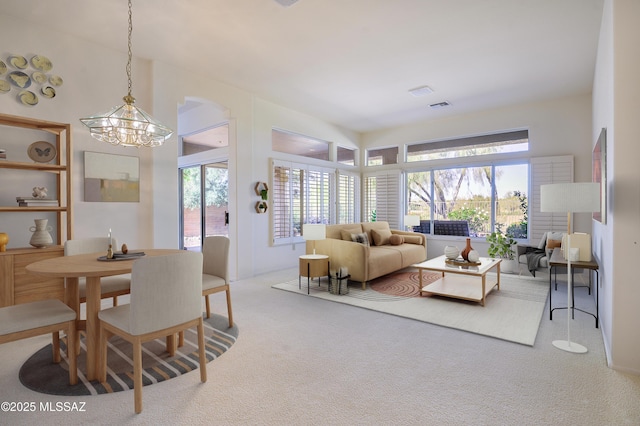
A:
[98, 251, 207, 413]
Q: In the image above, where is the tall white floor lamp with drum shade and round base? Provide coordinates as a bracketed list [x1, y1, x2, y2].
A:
[540, 182, 600, 353]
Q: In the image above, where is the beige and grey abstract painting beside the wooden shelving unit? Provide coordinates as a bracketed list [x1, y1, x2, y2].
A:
[84, 151, 140, 203]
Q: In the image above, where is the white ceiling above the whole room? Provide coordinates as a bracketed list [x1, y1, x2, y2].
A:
[1, 0, 604, 132]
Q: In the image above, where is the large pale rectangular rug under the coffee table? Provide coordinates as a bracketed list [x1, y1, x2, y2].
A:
[272, 272, 549, 346]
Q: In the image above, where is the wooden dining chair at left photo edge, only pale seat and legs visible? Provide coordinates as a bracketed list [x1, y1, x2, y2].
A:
[0, 299, 78, 385]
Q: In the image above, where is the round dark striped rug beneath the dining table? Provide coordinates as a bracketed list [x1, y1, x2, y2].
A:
[19, 314, 238, 395]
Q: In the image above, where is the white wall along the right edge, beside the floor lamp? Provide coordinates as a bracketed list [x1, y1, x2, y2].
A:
[592, 0, 640, 374]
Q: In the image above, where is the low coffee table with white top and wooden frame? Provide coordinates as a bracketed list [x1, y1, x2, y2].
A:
[413, 256, 502, 306]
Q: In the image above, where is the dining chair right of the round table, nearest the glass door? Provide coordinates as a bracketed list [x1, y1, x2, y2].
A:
[202, 235, 233, 328]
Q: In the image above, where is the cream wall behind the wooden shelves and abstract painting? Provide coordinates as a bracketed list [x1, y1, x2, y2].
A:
[0, 15, 153, 248]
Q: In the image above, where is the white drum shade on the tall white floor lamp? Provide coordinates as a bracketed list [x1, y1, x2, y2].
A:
[540, 182, 600, 213]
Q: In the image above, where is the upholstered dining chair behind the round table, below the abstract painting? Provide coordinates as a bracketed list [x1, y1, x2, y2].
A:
[64, 237, 131, 306]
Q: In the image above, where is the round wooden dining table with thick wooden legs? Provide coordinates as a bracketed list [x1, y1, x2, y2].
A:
[25, 249, 182, 380]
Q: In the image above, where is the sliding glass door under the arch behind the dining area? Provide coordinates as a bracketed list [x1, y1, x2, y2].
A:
[180, 161, 229, 251]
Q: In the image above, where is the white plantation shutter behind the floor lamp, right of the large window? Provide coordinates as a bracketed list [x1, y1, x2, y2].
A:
[529, 155, 573, 244]
